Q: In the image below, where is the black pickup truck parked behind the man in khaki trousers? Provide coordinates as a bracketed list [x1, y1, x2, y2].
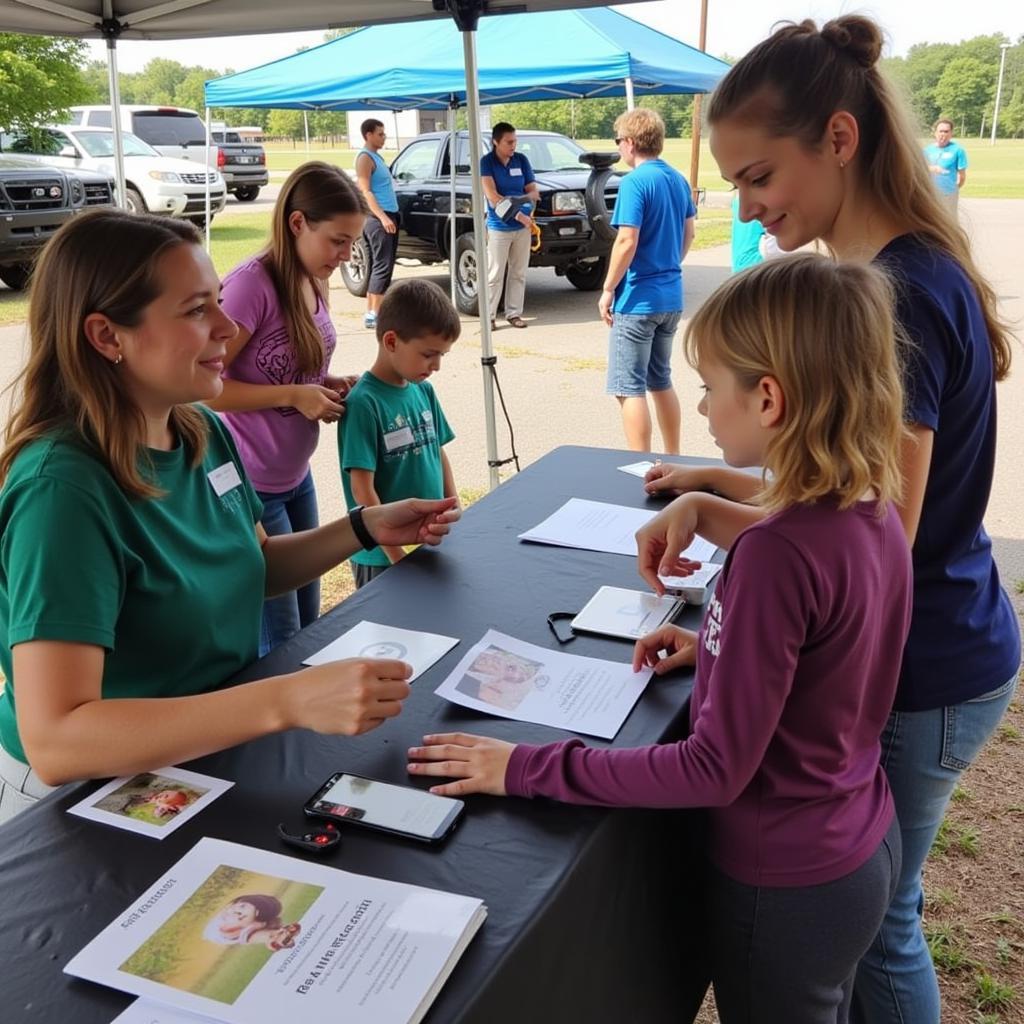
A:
[341, 130, 622, 316]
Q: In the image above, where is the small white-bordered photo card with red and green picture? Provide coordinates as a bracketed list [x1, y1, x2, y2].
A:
[68, 767, 234, 839]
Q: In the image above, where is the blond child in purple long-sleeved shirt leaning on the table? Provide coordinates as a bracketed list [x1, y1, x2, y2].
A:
[409, 255, 910, 1024]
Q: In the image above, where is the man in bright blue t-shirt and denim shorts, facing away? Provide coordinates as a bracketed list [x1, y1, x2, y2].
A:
[598, 108, 696, 455]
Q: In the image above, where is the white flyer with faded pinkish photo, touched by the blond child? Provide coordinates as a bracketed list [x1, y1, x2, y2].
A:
[434, 630, 651, 739]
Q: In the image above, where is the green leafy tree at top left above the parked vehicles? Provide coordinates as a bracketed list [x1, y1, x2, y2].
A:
[0, 33, 88, 128]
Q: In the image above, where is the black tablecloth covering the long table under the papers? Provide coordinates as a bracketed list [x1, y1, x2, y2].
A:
[0, 447, 720, 1024]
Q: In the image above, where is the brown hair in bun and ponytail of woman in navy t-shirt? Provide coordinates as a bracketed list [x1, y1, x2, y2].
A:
[708, 14, 1012, 381]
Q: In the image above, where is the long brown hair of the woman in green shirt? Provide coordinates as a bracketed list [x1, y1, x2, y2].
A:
[0, 210, 207, 498]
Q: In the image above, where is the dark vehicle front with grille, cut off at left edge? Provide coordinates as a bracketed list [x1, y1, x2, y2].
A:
[0, 156, 114, 291]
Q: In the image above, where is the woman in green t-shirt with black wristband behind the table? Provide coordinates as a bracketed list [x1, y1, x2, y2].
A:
[0, 210, 459, 820]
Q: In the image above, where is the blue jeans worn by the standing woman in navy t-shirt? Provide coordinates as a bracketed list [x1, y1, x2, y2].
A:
[851, 675, 1017, 1024]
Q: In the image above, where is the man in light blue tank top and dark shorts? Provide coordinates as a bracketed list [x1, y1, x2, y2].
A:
[355, 118, 400, 328]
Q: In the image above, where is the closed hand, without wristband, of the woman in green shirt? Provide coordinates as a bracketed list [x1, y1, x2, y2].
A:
[280, 657, 413, 736]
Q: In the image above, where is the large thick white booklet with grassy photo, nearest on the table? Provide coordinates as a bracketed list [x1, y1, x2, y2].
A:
[65, 839, 486, 1024]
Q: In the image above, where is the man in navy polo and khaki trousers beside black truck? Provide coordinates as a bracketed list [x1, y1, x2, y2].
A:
[480, 121, 541, 328]
